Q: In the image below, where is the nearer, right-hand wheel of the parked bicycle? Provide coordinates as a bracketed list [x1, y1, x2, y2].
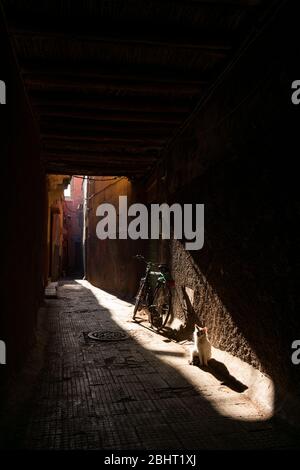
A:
[150, 283, 171, 331]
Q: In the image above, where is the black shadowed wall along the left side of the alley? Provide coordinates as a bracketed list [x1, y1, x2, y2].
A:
[0, 10, 46, 388]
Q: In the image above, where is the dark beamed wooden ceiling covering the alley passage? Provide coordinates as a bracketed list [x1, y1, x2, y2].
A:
[2, 0, 274, 177]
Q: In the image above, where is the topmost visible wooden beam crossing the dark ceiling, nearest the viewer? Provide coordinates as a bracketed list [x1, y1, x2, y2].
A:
[8, 22, 232, 56]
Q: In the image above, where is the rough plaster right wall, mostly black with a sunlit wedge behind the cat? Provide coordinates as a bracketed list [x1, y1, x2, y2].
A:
[149, 4, 300, 413]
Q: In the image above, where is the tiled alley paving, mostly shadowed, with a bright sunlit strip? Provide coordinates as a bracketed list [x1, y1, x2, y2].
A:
[8, 281, 297, 450]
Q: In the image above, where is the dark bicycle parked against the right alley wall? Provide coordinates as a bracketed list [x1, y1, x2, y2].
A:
[133, 255, 174, 331]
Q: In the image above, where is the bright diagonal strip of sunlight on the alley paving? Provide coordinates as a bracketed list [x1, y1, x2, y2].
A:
[73, 280, 270, 422]
